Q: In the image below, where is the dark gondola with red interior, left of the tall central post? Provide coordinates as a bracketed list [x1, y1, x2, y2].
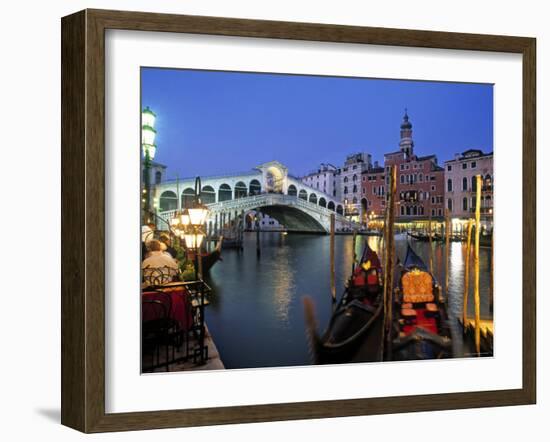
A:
[304, 245, 383, 364]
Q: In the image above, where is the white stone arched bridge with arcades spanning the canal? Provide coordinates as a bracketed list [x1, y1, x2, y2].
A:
[154, 161, 359, 233]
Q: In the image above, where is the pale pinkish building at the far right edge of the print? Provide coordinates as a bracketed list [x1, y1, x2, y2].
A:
[445, 149, 493, 219]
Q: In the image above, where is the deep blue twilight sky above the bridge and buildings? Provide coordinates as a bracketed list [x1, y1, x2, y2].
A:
[141, 68, 493, 178]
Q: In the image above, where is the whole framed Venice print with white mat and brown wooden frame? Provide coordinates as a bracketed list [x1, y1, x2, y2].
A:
[61, 10, 536, 432]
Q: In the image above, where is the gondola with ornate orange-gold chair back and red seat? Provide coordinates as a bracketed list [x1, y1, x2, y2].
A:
[385, 245, 453, 360]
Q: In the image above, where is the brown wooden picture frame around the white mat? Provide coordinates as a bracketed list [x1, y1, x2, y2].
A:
[61, 10, 536, 432]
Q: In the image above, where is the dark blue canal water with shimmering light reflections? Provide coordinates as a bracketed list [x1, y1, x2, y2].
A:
[206, 233, 496, 368]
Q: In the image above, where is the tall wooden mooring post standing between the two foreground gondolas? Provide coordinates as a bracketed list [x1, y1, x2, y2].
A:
[383, 166, 396, 360]
